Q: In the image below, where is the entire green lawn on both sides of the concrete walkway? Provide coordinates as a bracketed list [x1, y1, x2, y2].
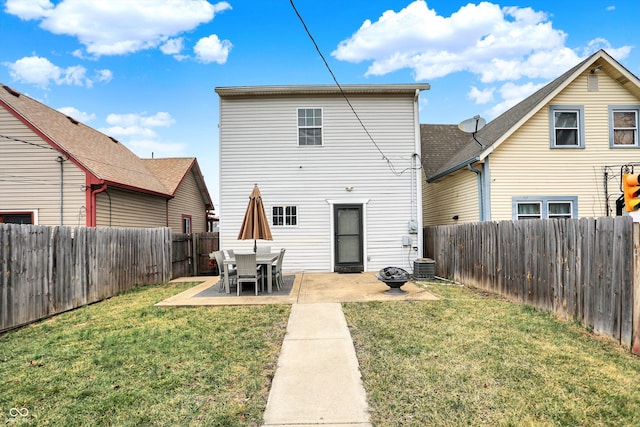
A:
[0, 283, 640, 426]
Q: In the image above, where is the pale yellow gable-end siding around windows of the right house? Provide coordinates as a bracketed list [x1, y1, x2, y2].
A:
[490, 72, 640, 220]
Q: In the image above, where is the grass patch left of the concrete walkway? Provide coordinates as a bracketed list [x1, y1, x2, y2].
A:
[0, 283, 290, 426]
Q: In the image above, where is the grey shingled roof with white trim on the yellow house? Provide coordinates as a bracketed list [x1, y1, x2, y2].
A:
[421, 50, 640, 182]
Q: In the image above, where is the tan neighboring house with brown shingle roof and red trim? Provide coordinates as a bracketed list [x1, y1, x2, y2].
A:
[0, 86, 213, 232]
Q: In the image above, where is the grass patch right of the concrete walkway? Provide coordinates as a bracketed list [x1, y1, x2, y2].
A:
[343, 283, 640, 427]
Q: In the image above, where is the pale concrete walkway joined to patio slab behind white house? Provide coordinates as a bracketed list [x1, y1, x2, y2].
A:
[156, 273, 437, 427]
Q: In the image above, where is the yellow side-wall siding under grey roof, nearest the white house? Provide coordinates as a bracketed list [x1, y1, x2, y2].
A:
[422, 169, 480, 226]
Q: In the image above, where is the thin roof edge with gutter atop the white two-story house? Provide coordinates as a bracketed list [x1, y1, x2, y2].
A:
[215, 83, 431, 98]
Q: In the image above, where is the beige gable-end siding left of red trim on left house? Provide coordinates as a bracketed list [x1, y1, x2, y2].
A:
[0, 108, 86, 226]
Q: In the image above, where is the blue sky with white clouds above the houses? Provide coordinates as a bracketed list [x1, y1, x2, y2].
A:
[0, 0, 640, 204]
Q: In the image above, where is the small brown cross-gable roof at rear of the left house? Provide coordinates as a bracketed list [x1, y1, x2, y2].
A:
[141, 157, 213, 209]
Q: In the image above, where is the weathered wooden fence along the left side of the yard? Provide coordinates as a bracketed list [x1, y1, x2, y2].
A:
[0, 224, 171, 331]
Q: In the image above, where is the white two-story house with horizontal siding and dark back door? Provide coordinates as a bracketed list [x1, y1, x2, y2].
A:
[216, 84, 429, 272]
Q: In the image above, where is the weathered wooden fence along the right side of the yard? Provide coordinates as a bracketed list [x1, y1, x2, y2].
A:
[425, 216, 640, 352]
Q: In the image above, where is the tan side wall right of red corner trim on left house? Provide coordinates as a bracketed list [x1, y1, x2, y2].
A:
[96, 188, 167, 227]
